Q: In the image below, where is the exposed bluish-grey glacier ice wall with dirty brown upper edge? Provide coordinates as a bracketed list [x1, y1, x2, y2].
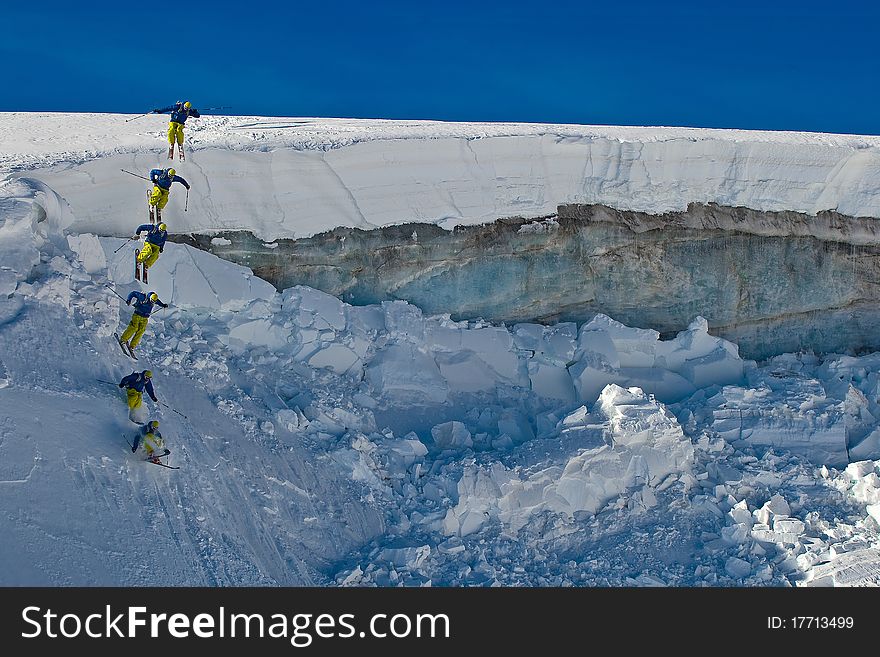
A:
[175, 205, 880, 359]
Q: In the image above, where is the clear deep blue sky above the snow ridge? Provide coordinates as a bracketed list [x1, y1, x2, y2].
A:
[0, 0, 880, 135]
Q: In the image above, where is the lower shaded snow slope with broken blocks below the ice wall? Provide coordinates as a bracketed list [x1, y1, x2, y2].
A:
[0, 168, 880, 586]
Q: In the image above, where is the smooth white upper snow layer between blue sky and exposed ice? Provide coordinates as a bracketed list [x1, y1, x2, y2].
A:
[6, 113, 880, 241]
